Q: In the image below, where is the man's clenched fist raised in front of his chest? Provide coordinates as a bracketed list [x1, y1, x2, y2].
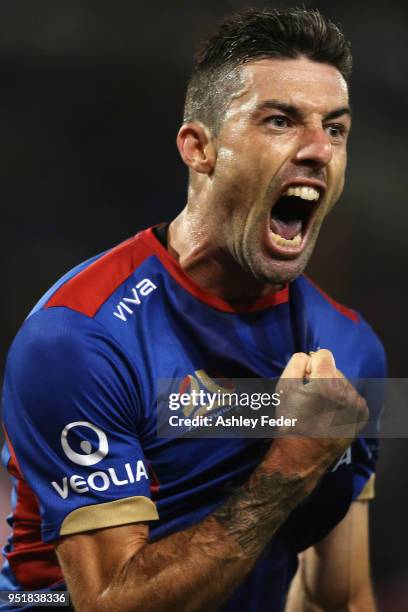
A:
[264, 349, 368, 486]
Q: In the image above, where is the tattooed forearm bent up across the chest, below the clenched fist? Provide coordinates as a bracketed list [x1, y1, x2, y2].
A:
[93, 444, 318, 612]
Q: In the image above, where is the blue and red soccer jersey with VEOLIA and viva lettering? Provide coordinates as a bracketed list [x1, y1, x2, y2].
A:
[0, 228, 385, 612]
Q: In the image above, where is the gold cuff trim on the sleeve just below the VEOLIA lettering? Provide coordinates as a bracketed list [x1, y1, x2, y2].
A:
[60, 495, 159, 536]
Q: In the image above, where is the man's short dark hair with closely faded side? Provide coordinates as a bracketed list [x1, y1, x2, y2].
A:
[184, 8, 352, 133]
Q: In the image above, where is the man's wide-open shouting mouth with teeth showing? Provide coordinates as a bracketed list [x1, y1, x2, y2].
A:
[270, 185, 321, 252]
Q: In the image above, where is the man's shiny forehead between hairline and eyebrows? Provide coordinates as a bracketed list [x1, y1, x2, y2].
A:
[229, 57, 348, 114]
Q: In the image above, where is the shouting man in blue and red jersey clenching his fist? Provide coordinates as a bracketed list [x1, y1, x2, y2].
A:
[0, 9, 384, 612]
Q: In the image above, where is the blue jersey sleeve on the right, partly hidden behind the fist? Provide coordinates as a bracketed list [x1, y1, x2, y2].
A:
[352, 319, 387, 501]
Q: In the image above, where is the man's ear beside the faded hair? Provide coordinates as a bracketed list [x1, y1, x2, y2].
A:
[177, 122, 217, 174]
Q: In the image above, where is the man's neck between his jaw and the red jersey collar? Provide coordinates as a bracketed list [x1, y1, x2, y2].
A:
[168, 205, 282, 306]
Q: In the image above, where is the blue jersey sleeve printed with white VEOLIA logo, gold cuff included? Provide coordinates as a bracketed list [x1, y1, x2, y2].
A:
[3, 307, 158, 542]
